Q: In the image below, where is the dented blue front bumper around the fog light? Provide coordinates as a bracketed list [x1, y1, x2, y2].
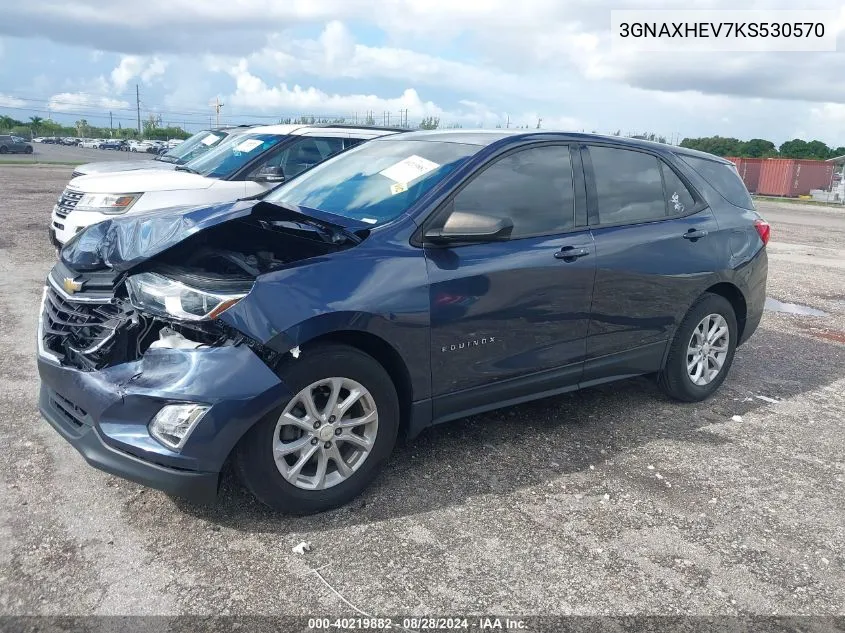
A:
[38, 338, 292, 502]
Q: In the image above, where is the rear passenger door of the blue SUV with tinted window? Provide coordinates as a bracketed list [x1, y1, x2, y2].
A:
[582, 145, 719, 383]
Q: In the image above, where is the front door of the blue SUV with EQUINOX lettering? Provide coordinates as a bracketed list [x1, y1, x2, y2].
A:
[425, 145, 595, 418]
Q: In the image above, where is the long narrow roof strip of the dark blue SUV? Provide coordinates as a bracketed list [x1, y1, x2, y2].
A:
[380, 128, 730, 164]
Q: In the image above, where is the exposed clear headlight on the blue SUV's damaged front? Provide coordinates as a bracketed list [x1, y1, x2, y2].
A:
[126, 273, 247, 321]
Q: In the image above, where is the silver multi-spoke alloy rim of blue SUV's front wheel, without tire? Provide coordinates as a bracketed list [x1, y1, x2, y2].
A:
[273, 377, 378, 490]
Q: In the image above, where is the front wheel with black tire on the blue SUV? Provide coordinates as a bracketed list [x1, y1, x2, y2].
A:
[234, 344, 399, 514]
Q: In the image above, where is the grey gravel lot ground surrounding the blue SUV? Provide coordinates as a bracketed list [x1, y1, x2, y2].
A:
[0, 165, 845, 616]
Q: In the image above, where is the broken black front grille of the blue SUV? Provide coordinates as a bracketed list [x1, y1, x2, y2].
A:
[41, 285, 123, 358]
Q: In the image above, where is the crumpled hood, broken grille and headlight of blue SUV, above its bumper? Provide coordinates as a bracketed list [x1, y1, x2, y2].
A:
[39, 202, 363, 371]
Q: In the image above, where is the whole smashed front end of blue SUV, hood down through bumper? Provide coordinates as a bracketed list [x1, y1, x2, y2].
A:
[38, 202, 366, 501]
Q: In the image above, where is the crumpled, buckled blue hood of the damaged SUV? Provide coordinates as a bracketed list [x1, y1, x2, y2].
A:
[61, 200, 372, 272]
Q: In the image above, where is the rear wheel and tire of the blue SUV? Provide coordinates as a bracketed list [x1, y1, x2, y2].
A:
[657, 293, 739, 402]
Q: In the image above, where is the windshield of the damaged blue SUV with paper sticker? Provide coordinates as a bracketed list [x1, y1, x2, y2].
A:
[264, 139, 481, 224]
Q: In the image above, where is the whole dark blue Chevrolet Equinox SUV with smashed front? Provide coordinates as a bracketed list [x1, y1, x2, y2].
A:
[38, 130, 769, 513]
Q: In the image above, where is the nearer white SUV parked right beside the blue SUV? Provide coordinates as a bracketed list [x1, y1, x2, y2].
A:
[51, 125, 395, 244]
